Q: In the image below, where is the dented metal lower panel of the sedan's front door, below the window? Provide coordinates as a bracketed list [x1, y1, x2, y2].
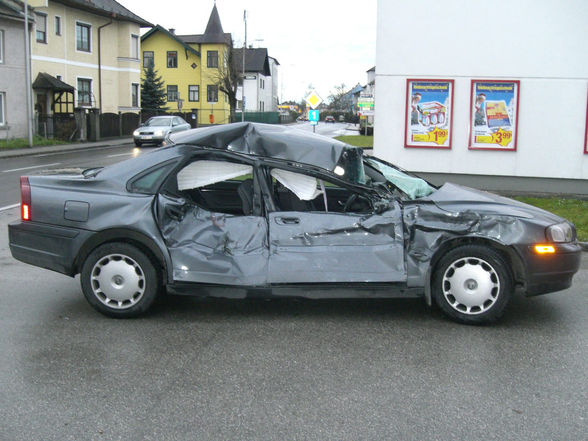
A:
[269, 209, 406, 283]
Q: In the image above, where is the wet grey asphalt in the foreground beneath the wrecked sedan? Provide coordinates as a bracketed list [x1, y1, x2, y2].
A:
[0, 202, 588, 441]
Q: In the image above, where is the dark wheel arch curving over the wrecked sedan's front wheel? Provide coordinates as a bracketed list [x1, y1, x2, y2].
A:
[425, 236, 526, 306]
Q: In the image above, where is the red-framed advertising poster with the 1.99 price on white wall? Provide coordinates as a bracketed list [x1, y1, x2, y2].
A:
[404, 79, 453, 149]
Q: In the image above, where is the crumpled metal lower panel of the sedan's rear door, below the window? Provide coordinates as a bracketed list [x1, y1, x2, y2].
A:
[156, 200, 268, 285]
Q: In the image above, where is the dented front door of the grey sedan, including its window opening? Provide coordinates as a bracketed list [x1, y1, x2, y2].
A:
[268, 168, 406, 284]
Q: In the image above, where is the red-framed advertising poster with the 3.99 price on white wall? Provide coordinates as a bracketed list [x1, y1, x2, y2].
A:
[470, 80, 519, 151]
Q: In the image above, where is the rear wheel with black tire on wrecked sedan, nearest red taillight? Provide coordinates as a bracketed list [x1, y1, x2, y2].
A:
[80, 242, 161, 318]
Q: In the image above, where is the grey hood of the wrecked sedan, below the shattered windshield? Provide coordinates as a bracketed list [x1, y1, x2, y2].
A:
[420, 183, 565, 224]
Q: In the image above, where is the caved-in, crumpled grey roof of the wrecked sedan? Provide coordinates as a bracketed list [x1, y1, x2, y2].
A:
[171, 122, 357, 170]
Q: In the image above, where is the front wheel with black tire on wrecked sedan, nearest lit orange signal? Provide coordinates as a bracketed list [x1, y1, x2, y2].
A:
[431, 245, 513, 325]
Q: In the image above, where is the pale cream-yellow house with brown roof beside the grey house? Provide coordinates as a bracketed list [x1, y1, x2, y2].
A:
[32, 0, 153, 114]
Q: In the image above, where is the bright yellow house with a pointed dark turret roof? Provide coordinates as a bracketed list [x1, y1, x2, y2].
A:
[141, 5, 232, 125]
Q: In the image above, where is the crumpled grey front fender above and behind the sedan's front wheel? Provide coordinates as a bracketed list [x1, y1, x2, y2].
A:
[404, 204, 528, 286]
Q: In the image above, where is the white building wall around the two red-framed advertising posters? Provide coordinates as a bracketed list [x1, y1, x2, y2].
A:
[374, 0, 588, 179]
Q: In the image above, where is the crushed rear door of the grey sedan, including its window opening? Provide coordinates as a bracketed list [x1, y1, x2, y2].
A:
[157, 158, 268, 286]
